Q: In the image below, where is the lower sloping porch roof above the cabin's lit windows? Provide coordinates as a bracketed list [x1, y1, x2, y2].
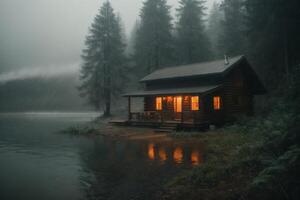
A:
[123, 85, 221, 97]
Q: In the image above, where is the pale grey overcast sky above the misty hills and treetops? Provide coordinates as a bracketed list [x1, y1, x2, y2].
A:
[0, 0, 220, 80]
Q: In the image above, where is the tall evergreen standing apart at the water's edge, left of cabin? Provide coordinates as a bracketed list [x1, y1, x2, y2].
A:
[79, 1, 125, 116]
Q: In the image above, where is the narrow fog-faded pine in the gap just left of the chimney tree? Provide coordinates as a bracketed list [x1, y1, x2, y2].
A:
[207, 2, 224, 58]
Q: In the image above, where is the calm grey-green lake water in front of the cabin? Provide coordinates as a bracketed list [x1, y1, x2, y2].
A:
[0, 113, 202, 200]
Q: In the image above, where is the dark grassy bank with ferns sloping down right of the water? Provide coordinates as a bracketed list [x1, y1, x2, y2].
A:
[161, 100, 300, 200]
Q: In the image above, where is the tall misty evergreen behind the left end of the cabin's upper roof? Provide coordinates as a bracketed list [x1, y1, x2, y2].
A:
[135, 0, 173, 75]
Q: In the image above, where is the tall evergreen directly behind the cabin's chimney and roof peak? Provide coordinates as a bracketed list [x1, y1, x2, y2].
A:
[219, 0, 246, 56]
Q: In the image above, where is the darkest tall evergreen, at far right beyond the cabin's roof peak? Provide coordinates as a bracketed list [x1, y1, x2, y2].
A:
[245, 0, 300, 85]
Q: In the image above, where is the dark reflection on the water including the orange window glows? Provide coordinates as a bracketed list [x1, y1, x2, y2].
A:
[80, 137, 202, 200]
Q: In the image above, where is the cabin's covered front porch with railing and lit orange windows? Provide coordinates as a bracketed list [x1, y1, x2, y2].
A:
[121, 93, 221, 128]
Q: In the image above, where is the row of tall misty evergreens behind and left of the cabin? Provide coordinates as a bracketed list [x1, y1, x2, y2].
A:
[79, 0, 300, 116]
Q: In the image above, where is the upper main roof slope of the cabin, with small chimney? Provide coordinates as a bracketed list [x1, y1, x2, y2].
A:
[140, 55, 244, 82]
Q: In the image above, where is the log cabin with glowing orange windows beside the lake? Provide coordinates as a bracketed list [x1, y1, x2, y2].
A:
[124, 56, 266, 127]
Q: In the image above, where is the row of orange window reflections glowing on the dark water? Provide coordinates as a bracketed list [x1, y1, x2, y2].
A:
[148, 142, 202, 165]
